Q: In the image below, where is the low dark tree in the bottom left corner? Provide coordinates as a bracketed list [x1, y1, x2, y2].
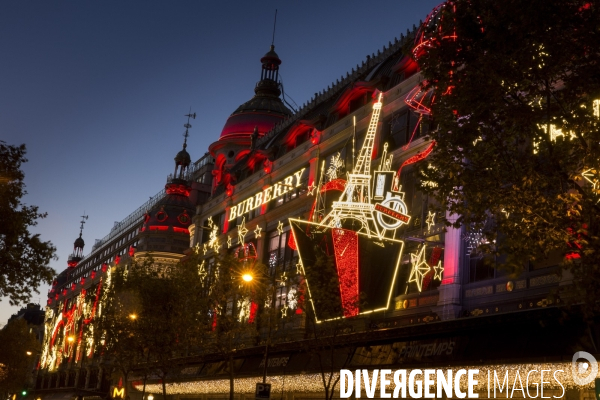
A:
[0, 319, 40, 398]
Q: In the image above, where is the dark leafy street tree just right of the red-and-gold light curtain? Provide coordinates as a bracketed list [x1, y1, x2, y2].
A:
[121, 260, 209, 399]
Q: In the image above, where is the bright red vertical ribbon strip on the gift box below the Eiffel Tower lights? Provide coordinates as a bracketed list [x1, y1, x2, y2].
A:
[332, 229, 358, 317]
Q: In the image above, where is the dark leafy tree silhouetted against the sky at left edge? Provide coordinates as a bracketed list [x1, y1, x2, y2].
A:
[0, 141, 57, 305]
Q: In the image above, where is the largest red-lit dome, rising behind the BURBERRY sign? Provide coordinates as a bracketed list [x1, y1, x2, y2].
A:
[209, 45, 292, 191]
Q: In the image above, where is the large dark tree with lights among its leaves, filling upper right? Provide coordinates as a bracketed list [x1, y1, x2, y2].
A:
[407, 0, 600, 311]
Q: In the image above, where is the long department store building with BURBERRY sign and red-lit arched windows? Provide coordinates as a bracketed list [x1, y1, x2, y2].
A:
[38, 3, 600, 400]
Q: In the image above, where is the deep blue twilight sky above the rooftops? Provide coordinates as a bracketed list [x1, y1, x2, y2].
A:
[0, 0, 441, 324]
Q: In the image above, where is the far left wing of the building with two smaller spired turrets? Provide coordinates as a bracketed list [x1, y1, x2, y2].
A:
[35, 138, 214, 399]
